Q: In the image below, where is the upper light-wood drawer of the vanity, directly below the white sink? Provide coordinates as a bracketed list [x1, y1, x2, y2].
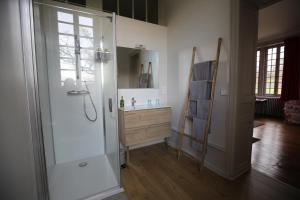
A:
[124, 108, 171, 128]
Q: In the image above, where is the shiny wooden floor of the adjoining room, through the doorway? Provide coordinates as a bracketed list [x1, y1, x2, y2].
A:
[252, 118, 300, 189]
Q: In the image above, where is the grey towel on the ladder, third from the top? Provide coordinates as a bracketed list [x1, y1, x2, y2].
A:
[190, 99, 211, 120]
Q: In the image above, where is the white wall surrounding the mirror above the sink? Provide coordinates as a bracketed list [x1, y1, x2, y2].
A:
[116, 16, 168, 105]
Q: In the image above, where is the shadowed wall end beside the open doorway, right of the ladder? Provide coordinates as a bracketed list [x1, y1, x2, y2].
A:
[226, 0, 258, 179]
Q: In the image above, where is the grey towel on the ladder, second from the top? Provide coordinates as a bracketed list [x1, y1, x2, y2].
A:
[190, 81, 212, 100]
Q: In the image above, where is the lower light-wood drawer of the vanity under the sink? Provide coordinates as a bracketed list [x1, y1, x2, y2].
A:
[124, 123, 170, 145]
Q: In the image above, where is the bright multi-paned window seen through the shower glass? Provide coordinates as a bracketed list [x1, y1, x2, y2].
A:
[57, 11, 95, 85]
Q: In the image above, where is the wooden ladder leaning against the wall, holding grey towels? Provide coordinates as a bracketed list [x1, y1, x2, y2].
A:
[177, 38, 222, 170]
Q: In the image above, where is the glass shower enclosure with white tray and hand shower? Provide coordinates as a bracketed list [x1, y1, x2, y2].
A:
[33, 1, 121, 200]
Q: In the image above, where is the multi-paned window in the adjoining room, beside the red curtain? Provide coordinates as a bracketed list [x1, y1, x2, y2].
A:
[255, 43, 284, 97]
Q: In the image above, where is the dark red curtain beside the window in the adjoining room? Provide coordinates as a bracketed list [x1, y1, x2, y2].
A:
[281, 37, 300, 101]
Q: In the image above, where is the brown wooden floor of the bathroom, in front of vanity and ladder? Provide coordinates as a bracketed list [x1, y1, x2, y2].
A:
[122, 144, 300, 200]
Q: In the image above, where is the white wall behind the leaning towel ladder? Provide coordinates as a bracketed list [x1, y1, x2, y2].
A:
[166, 0, 230, 174]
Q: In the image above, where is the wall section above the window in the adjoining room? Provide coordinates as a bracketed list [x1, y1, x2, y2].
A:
[258, 0, 300, 40]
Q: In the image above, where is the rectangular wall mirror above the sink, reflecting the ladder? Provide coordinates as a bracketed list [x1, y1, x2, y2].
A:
[117, 47, 159, 89]
